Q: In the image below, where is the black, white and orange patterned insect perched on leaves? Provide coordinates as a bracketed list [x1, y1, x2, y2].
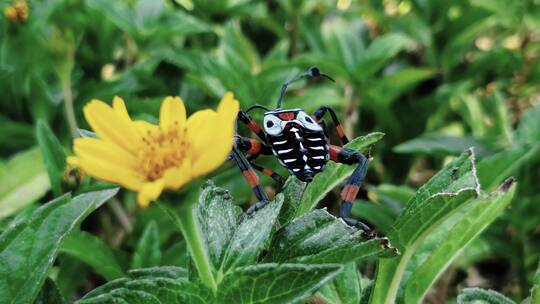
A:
[231, 67, 372, 236]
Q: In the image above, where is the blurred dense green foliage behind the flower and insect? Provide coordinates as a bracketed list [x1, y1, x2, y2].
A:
[0, 0, 540, 303]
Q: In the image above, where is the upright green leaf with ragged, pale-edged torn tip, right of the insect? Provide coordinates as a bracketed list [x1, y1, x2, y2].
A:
[371, 150, 480, 303]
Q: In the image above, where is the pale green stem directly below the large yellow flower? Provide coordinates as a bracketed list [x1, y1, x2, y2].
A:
[178, 204, 217, 292]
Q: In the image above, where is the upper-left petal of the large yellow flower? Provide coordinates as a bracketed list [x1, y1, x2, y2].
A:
[83, 100, 142, 153]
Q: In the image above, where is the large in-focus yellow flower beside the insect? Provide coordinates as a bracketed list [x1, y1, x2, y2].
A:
[68, 92, 239, 207]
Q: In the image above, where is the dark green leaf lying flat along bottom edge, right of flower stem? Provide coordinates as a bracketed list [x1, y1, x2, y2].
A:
[218, 263, 342, 304]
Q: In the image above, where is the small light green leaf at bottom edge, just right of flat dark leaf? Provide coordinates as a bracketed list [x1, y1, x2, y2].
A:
[319, 263, 361, 304]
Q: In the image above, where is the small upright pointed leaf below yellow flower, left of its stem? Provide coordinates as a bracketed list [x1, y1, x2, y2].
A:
[131, 220, 161, 269]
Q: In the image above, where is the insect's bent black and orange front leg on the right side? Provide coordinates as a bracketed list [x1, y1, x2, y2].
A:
[330, 145, 373, 237]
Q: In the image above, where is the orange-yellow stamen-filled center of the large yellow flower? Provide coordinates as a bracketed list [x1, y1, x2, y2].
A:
[137, 128, 189, 181]
